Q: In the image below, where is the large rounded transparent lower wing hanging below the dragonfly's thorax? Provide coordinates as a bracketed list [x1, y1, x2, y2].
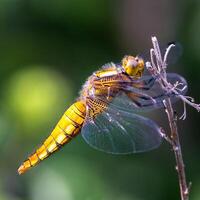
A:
[81, 104, 162, 154]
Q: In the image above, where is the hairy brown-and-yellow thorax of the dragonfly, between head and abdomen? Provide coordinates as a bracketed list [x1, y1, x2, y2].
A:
[79, 65, 126, 118]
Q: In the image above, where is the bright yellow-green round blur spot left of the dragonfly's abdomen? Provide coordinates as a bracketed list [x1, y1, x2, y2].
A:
[5, 66, 73, 134]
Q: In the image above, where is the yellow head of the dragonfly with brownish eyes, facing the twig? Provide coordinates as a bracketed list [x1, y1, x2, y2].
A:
[122, 56, 144, 79]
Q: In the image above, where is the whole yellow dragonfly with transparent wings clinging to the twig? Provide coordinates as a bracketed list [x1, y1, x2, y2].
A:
[18, 43, 187, 174]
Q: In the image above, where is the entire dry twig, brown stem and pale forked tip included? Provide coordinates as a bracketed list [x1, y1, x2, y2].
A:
[146, 37, 195, 200]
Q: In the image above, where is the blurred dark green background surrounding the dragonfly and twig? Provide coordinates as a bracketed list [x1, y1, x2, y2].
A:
[0, 0, 200, 200]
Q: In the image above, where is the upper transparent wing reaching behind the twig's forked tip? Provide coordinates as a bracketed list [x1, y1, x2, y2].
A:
[104, 73, 187, 112]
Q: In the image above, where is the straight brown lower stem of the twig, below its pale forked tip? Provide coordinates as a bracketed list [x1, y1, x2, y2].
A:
[164, 98, 189, 200]
